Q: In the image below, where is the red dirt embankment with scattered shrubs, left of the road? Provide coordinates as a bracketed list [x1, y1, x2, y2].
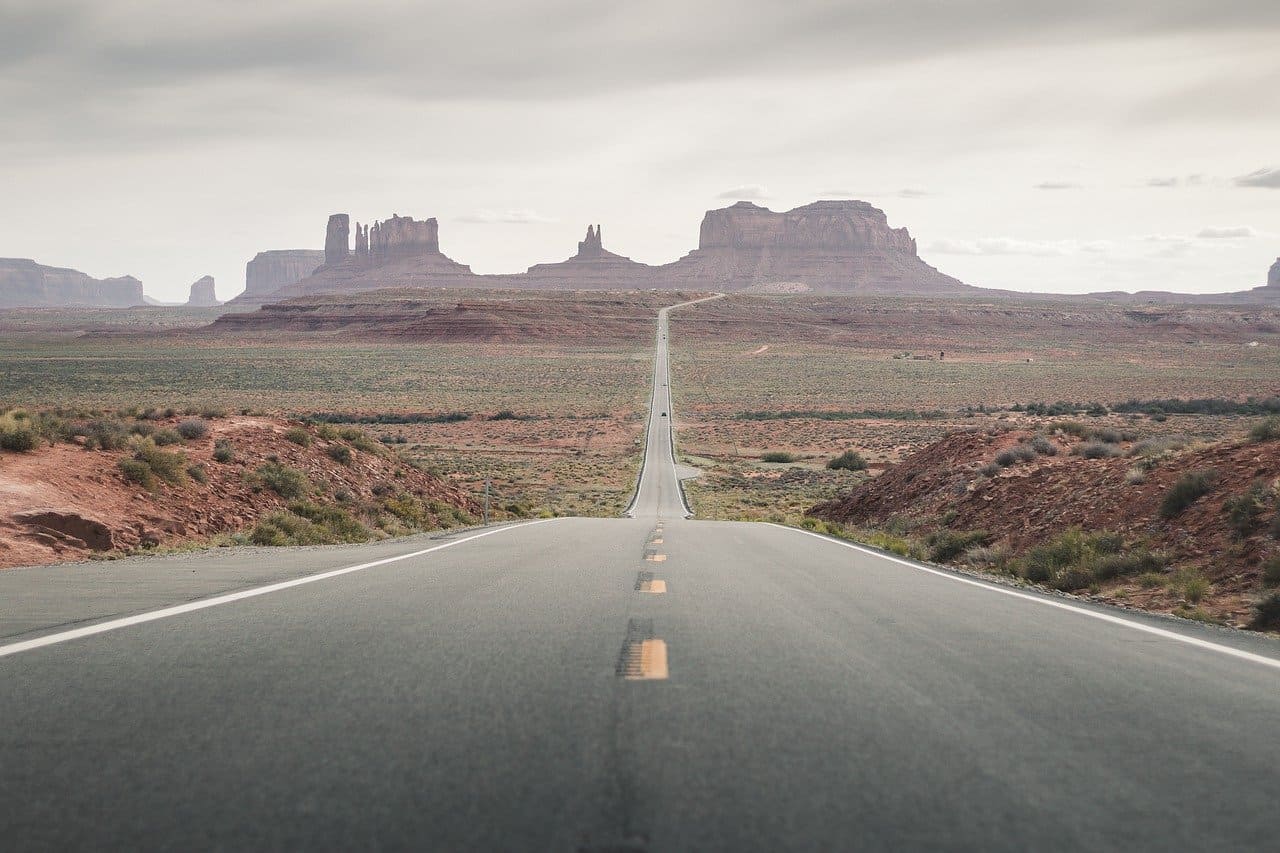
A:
[0, 416, 479, 569]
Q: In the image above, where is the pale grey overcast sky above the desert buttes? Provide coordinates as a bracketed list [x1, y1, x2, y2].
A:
[0, 0, 1280, 300]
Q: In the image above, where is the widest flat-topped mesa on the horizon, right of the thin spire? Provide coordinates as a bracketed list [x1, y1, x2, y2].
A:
[662, 201, 982, 296]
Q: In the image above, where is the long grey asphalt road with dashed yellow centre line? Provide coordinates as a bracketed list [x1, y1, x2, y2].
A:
[0, 295, 1280, 852]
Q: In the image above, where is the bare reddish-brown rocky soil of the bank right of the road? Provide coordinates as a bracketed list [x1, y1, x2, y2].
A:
[812, 430, 1280, 625]
